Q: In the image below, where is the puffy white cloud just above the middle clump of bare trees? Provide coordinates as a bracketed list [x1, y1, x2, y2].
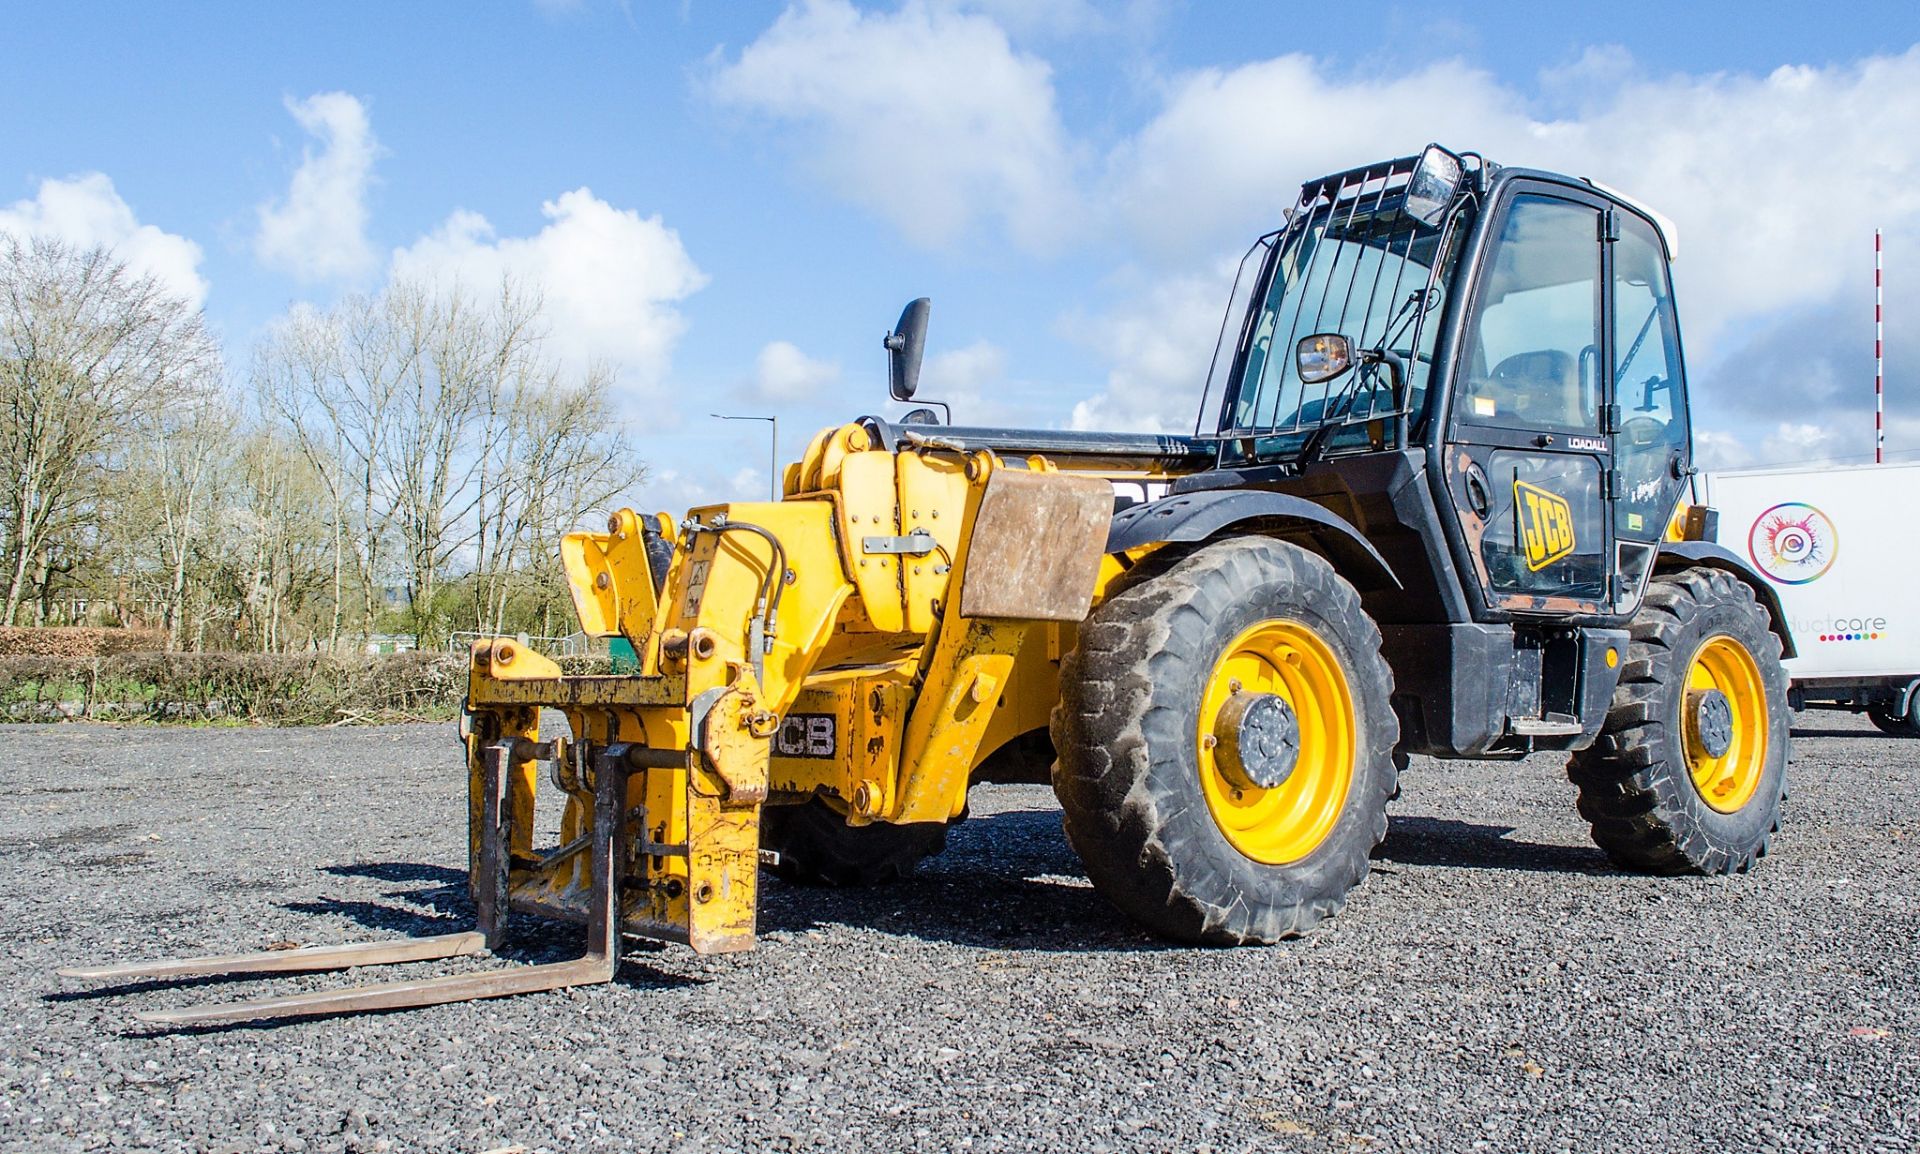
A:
[392, 188, 707, 394]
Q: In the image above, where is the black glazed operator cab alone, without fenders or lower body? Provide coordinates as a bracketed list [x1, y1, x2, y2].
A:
[1179, 146, 1692, 624]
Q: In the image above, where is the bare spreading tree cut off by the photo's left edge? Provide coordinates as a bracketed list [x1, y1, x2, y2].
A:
[0, 236, 219, 624]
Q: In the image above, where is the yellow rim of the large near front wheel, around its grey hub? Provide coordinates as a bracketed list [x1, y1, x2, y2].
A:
[1196, 620, 1359, 866]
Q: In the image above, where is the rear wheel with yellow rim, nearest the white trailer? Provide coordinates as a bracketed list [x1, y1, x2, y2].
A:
[1567, 568, 1791, 874]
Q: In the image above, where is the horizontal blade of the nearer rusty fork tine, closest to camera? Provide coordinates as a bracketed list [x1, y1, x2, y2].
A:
[134, 954, 616, 1025]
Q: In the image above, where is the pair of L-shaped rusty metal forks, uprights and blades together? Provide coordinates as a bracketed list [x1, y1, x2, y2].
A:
[60, 737, 632, 1027]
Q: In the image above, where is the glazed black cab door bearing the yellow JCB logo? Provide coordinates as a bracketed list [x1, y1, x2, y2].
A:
[1446, 182, 1613, 614]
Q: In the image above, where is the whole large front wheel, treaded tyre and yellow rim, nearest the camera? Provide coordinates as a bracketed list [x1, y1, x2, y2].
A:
[1052, 538, 1400, 945]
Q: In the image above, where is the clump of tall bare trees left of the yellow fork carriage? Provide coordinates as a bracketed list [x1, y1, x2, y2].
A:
[252, 270, 641, 645]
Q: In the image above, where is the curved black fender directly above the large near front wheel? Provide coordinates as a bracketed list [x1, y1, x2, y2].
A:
[1106, 490, 1402, 589]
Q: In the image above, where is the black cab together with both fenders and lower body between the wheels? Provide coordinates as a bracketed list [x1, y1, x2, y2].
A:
[1167, 146, 1784, 757]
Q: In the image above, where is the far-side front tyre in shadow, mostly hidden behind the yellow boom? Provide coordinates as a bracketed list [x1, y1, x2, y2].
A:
[760, 797, 947, 887]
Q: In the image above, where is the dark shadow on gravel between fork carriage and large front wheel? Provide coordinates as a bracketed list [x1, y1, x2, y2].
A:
[760, 810, 1179, 952]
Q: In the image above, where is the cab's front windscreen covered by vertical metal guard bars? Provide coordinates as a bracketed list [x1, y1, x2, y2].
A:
[1219, 159, 1444, 455]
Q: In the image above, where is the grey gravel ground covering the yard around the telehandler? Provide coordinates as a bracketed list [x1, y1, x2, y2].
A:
[0, 714, 1920, 1152]
